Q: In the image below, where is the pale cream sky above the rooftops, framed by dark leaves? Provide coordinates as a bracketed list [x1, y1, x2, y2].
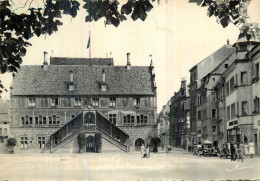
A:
[0, 0, 260, 113]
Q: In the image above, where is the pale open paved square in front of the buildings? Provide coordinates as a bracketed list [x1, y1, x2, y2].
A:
[0, 149, 260, 181]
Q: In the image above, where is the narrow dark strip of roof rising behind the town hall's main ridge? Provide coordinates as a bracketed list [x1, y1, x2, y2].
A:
[50, 57, 114, 65]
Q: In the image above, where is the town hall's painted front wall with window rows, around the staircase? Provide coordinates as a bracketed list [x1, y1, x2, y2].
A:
[10, 96, 156, 150]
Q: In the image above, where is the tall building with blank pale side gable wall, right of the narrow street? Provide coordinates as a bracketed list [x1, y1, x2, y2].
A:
[189, 42, 235, 145]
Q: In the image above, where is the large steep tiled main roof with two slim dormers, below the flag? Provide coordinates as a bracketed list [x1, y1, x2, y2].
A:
[12, 65, 154, 95]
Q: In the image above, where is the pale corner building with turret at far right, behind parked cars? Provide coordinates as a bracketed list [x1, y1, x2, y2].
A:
[215, 39, 259, 153]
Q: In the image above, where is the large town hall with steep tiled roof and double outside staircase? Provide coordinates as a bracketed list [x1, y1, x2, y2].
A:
[10, 54, 157, 151]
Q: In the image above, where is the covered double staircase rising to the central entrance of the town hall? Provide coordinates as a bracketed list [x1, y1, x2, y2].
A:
[50, 111, 129, 153]
